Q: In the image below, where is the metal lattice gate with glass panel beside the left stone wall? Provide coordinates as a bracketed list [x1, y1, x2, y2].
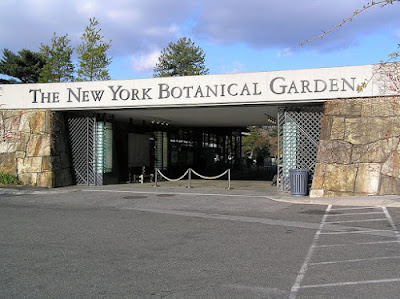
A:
[67, 115, 104, 185]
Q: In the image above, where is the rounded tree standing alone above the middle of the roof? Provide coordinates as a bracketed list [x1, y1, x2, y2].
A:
[153, 37, 209, 77]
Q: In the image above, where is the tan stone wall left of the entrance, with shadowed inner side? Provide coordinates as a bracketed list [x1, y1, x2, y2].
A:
[0, 110, 72, 187]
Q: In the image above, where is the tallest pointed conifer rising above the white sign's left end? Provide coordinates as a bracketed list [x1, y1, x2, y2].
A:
[76, 18, 112, 81]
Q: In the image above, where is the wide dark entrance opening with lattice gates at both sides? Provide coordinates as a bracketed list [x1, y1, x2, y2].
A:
[63, 104, 322, 191]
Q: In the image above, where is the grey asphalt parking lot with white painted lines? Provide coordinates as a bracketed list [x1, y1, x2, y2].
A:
[0, 186, 400, 298]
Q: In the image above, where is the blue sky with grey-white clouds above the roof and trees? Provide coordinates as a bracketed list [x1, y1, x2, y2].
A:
[0, 0, 400, 80]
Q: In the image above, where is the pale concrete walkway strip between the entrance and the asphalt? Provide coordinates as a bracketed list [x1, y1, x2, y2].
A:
[0, 180, 400, 208]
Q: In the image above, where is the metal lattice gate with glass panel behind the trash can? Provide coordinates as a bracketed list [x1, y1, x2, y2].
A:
[277, 105, 323, 191]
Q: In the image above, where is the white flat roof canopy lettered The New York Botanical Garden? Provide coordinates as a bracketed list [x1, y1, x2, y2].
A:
[0, 65, 393, 127]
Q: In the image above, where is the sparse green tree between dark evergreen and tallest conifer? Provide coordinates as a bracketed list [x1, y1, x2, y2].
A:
[40, 33, 74, 83]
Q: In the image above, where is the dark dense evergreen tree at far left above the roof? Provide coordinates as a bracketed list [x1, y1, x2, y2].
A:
[0, 49, 46, 83]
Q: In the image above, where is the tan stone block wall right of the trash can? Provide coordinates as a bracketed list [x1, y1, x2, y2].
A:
[310, 97, 400, 197]
